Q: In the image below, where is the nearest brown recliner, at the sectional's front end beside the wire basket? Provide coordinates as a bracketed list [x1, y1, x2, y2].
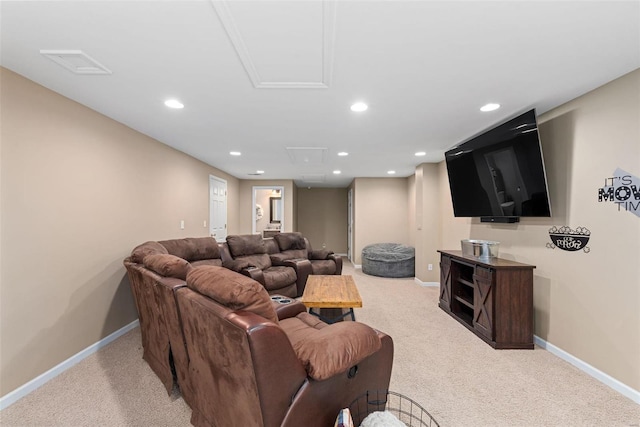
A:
[176, 266, 393, 427]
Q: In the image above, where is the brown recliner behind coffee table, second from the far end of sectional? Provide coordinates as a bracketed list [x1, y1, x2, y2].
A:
[223, 234, 312, 297]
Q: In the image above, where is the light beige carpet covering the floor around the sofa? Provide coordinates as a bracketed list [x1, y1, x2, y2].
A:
[0, 262, 640, 427]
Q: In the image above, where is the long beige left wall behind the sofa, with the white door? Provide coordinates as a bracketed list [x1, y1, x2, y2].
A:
[0, 68, 239, 395]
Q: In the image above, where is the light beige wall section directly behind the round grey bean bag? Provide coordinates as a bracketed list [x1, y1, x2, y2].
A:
[352, 178, 410, 264]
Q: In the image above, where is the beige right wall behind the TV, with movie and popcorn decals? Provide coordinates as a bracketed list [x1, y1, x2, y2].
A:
[440, 70, 640, 390]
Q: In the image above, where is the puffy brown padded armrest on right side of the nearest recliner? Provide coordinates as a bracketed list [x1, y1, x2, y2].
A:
[293, 322, 382, 381]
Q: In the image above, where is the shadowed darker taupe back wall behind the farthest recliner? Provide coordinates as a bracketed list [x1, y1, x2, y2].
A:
[297, 188, 348, 254]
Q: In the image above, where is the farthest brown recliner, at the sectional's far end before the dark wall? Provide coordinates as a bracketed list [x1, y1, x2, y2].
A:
[273, 232, 342, 275]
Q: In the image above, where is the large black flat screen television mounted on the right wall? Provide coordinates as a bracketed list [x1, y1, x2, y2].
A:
[445, 110, 551, 222]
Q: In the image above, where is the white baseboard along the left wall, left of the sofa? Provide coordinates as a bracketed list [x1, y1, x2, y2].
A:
[0, 319, 140, 411]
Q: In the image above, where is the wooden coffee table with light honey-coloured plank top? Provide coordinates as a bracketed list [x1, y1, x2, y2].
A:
[300, 274, 362, 323]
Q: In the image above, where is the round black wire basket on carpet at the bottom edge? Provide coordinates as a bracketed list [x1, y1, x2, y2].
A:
[349, 390, 440, 427]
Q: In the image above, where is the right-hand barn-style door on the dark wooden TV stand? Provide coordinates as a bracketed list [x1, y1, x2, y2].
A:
[473, 266, 495, 341]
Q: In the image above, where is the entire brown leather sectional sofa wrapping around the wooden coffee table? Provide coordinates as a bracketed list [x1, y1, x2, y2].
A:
[124, 233, 393, 426]
